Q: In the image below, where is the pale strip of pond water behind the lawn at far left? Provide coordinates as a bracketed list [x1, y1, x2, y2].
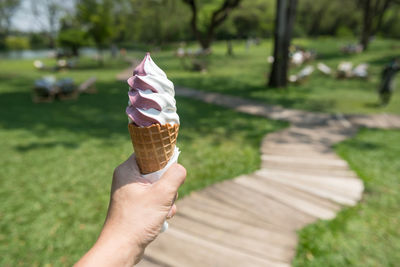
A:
[0, 47, 97, 59]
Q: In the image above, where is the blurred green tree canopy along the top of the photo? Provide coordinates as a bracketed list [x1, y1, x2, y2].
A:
[0, 0, 400, 49]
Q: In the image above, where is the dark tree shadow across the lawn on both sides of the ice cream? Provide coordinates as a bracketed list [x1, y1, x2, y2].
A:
[0, 74, 279, 151]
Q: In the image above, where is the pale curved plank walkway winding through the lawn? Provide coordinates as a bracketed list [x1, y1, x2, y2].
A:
[138, 88, 400, 267]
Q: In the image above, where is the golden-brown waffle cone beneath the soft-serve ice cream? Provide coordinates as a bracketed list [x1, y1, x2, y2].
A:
[128, 123, 179, 174]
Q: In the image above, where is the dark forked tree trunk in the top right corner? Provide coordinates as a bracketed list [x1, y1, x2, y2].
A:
[359, 0, 400, 50]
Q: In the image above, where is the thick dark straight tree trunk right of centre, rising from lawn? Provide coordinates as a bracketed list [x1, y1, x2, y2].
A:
[268, 0, 297, 87]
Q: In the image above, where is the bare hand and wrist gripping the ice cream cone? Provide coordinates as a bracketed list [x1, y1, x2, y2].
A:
[76, 155, 186, 266]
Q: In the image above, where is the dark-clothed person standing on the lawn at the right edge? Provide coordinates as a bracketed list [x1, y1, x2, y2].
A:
[379, 59, 400, 106]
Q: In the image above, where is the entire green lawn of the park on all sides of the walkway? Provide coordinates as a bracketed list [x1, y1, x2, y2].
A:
[0, 39, 400, 266]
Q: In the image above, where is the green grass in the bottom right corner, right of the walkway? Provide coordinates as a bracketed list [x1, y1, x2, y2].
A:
[294, 129, 400, 267]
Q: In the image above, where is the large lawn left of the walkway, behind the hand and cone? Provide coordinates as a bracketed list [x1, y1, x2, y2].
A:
[0, 55, 286, 266]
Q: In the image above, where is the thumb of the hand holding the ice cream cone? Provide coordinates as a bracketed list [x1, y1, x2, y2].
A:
[153, 163, 186, 201]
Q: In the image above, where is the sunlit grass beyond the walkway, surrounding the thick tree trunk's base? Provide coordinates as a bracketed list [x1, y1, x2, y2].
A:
[155, 38, 400, 114]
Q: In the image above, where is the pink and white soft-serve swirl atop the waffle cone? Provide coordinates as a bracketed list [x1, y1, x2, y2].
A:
[126, 53, 179, 127]
